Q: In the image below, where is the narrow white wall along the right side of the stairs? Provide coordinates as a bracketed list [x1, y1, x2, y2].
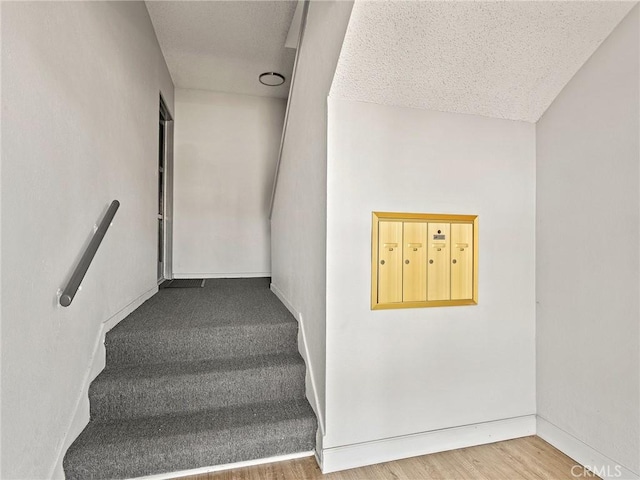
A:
[271, 1, 353, 442]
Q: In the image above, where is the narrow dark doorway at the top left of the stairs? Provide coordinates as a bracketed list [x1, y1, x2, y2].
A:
[157, 95, 173, 284]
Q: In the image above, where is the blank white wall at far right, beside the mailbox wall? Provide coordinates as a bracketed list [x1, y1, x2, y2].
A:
[536, 6, 640, 478]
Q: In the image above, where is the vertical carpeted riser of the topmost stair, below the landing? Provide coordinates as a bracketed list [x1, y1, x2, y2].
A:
[105, 316, 298, 366]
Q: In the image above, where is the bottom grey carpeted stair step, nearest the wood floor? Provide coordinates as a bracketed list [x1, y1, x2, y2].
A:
[64, 399, 317, 480]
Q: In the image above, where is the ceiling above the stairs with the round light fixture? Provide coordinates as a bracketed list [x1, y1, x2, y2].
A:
[146, 0, 297, 98]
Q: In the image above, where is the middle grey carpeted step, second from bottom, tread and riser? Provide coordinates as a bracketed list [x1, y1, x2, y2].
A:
[89, 352, 305, 420]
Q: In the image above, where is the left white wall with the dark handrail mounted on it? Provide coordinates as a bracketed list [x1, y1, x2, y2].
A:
[0, 2, 173, 479]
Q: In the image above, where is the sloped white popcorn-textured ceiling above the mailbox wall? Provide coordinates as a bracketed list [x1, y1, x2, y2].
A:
[331, 0, 635, 122]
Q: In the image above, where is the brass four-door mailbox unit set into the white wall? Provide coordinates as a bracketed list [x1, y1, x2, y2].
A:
[371, 212, 478, 310]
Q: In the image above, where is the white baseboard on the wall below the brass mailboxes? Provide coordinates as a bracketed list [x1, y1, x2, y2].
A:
[320, 415, 536, 473]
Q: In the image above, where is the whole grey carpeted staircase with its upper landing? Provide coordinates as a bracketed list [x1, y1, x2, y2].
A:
[64, 278, 316, 479]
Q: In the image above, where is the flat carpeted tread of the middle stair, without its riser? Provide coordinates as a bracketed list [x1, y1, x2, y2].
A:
[94, 351, 304, 384]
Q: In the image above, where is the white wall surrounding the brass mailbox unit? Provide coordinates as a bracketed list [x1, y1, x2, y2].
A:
[324, 96, 535, 469]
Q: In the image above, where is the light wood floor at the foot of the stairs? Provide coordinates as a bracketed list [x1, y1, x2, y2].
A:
[176, 436, 599, 480]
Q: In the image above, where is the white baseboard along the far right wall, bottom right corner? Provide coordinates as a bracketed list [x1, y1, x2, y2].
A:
[537, 416, 640, 480]
